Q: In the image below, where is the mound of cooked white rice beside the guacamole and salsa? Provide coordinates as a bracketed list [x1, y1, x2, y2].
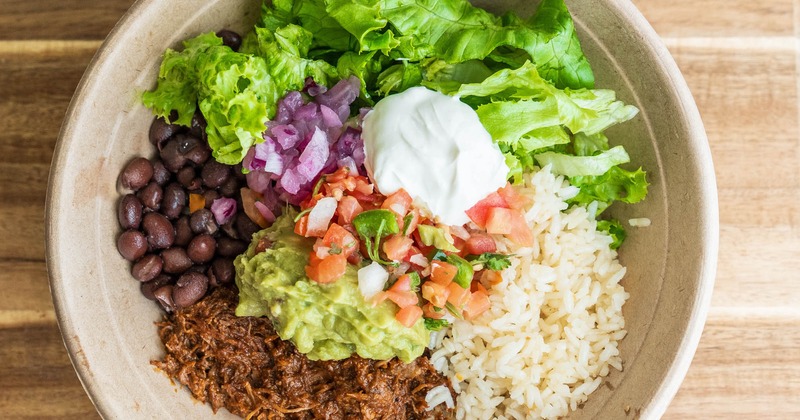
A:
[432, 167, 628, 419]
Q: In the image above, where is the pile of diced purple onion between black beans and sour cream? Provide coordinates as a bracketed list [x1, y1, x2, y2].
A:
[244, 76, 365, 207]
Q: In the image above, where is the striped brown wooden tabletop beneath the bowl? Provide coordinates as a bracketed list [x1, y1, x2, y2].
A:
[0, 0, 800, 419]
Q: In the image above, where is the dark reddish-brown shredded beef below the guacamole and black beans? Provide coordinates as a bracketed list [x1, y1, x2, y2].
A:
[152, 288, 455, 419]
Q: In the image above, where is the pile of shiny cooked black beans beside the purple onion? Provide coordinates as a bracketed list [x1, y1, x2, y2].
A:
[117, 108, 260, 312]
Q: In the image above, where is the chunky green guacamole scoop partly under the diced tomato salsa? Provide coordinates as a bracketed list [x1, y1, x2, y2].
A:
[235, 211, 429, 362]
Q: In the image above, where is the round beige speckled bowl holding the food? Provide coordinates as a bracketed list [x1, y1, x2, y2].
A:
[47, 0, 719, 419]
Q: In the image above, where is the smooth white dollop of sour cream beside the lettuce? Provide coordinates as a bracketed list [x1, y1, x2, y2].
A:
[362, 87, 508, 225]
